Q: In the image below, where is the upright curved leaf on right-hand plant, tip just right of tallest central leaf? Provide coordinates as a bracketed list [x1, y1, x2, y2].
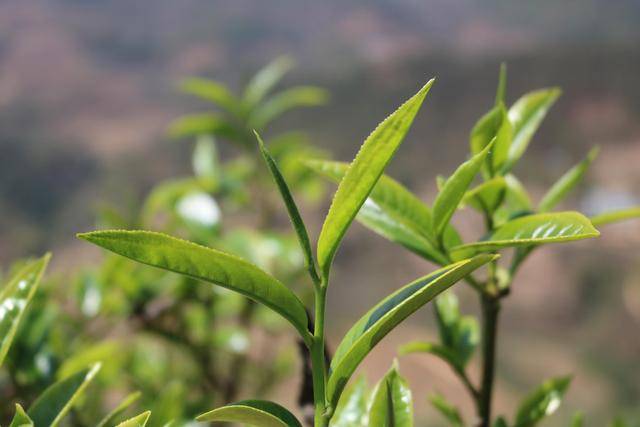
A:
[431, 144, 493, 236]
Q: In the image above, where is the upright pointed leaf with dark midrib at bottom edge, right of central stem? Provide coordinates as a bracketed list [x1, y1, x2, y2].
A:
[369, 363, 413, 427]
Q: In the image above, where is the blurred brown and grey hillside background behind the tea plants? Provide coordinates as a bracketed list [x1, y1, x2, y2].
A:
[0, 0, 640, 425]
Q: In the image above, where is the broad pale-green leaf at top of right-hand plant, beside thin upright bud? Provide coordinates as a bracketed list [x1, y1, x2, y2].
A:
[502, 88, 561, 175]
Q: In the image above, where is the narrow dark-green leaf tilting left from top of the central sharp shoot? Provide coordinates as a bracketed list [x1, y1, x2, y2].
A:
[256, 133, 319, 283]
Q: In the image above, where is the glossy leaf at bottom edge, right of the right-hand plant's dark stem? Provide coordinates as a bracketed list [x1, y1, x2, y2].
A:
[515, 377, 571, 427]
